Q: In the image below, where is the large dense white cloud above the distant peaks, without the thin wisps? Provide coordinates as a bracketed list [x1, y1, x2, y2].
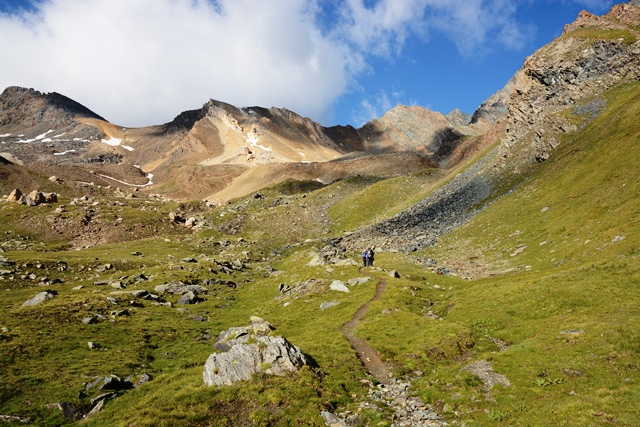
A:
[0, 0, 349, 126]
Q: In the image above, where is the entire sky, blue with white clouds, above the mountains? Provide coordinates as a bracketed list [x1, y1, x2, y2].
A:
[0, 0, 625, 127]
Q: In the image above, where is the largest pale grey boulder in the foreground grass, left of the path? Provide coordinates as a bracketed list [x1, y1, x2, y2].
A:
[202, 317, 310, 386]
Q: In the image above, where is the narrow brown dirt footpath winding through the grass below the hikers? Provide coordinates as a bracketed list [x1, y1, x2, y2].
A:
[340, 269, 393, 384]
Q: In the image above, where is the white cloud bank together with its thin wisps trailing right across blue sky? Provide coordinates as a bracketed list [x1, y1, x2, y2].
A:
[0, 0, 536, 126]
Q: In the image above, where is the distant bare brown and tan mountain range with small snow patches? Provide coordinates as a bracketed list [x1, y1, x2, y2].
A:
[0, 87, 477, 200]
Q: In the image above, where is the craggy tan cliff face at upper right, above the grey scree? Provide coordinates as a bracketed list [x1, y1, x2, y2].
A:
[497, 4, 640, 171]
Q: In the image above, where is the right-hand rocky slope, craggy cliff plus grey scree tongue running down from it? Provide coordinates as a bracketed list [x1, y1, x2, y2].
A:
[344, 3, 640, 254]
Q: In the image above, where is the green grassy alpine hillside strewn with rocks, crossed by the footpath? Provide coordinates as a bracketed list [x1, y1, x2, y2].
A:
[0, 83, 640, 426]
